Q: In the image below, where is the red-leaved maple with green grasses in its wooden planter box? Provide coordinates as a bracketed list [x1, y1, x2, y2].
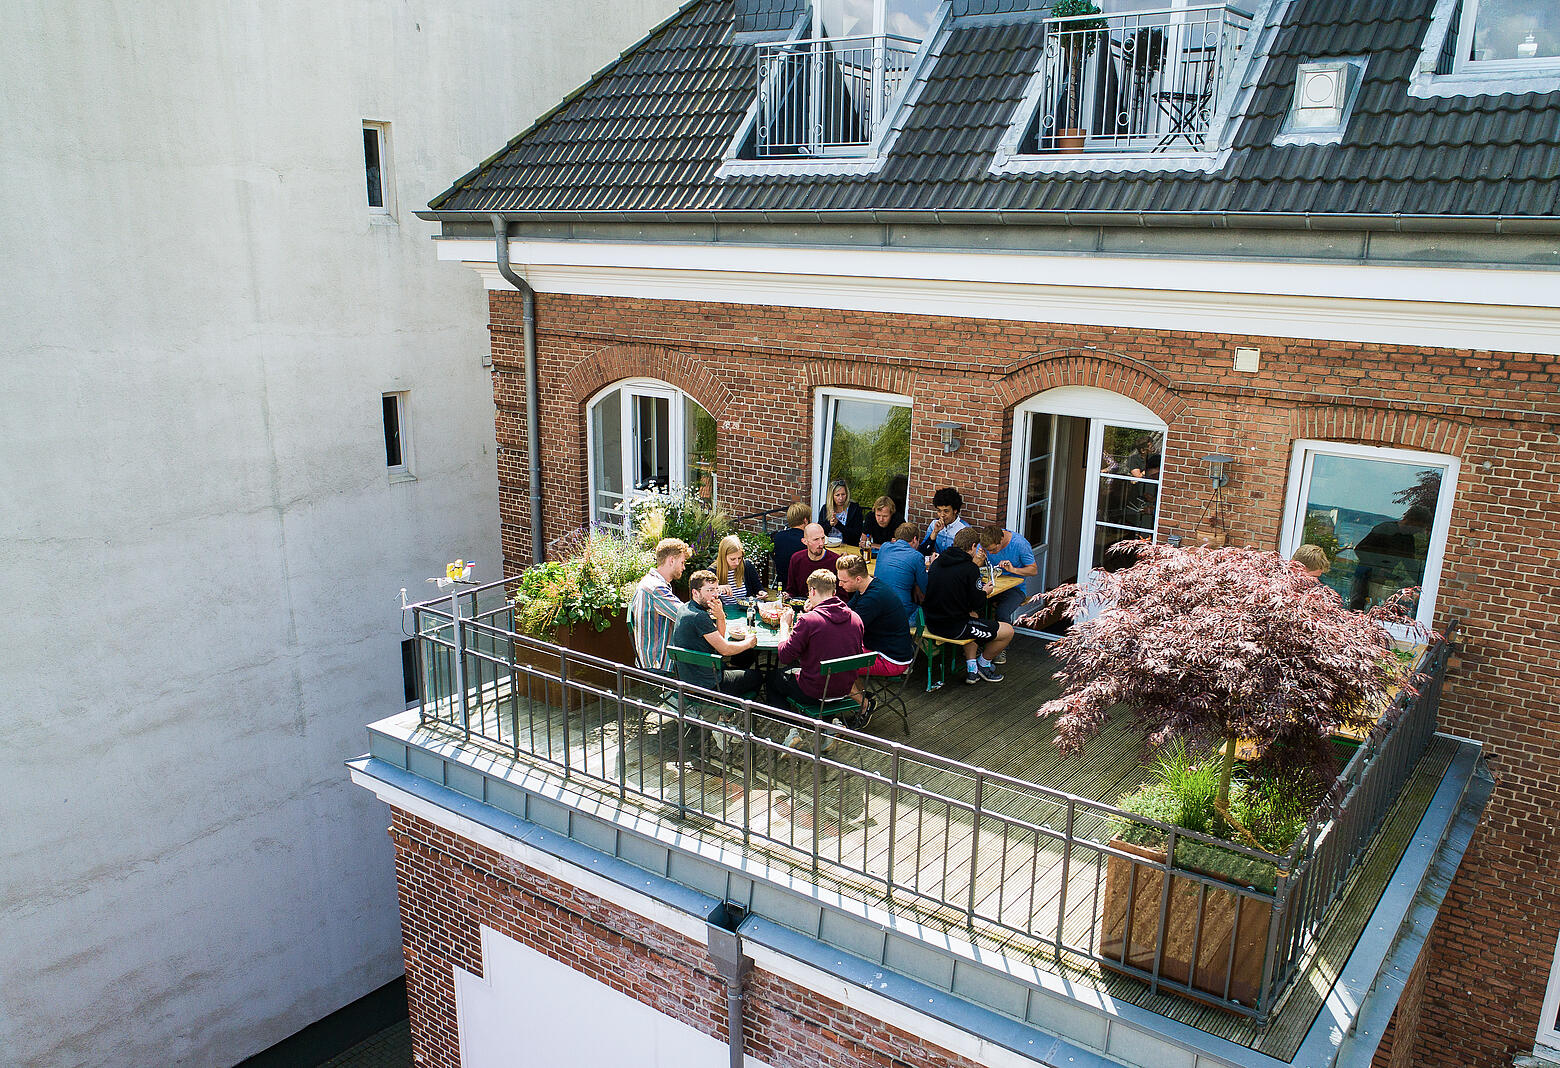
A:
[1039, 541, 1412, 1001]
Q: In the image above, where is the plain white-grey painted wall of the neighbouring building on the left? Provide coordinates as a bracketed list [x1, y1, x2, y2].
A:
[0, 0, 675, 1065]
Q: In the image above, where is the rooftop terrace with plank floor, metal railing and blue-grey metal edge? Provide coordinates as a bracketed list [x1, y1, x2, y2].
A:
[362, 586, 1477, 1063]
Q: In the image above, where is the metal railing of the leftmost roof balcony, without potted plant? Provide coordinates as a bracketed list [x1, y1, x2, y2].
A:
[758, 34, 919, 156]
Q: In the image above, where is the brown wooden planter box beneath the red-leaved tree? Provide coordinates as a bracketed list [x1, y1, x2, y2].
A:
[1100, 839, 1273, 1006]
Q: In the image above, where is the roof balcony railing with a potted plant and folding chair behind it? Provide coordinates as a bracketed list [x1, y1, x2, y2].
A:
[1036, 5, 1251, 151]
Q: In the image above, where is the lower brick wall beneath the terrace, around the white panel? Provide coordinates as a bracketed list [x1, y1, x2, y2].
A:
[390, 809, 977, 1068]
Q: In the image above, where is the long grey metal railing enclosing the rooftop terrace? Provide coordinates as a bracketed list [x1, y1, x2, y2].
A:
[412, 580, 1449, 1021]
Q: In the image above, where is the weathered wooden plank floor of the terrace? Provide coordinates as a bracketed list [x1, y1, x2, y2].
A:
[433, 641, 1453, 1056]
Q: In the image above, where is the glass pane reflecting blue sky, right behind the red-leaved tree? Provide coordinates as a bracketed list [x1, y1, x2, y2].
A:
[1301, 452, 1446, 610]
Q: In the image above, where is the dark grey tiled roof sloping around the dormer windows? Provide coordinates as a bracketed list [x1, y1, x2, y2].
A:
[431, 0, 1560, 221]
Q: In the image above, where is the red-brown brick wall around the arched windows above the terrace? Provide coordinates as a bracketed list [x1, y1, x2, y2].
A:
[490, 286, 1560, 1068]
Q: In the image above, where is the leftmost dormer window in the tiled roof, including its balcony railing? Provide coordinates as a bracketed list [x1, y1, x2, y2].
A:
[753, 0, 939, 157]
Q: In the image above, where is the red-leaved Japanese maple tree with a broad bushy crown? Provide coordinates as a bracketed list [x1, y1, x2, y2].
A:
[1034, 541, 1428, 835]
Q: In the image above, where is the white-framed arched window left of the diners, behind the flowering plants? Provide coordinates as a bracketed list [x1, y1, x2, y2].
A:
[585, 379, 714, 522]
